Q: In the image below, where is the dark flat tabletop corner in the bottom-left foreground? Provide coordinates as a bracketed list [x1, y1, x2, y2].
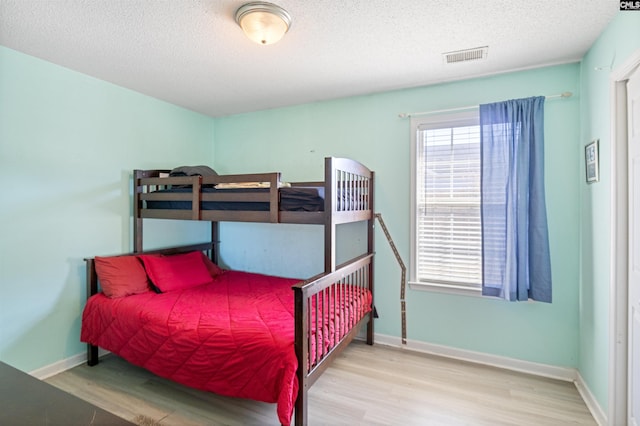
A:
[0, 362, 133, 426]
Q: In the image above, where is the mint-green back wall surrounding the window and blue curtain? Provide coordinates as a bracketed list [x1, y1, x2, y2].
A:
[214, 64, 582, 367]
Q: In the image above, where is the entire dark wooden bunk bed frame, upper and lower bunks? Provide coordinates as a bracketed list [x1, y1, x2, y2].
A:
[87, 157, 375, 425]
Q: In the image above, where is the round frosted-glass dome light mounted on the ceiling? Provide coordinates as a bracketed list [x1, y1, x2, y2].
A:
[236, 1, 291, 45]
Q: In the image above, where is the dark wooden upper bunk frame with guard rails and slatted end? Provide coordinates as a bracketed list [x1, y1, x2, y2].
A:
[133, 157, 375, 272]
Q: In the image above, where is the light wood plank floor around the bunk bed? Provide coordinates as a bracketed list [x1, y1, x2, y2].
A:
[46, 342, 596, 426]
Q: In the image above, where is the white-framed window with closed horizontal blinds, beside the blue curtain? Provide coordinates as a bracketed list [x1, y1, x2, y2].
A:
[409, 111, 482, 294]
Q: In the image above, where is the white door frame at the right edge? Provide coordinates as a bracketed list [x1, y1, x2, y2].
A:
[607, 50, 640, 425]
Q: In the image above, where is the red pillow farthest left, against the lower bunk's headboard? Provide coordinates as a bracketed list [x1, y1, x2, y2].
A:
[94, 256, 149, 297]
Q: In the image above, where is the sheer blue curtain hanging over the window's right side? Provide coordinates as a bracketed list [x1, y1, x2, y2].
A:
[480, 96, 551, 303]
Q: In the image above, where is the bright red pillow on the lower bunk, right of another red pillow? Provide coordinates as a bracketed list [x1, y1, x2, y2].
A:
[140, 251, 211, 293]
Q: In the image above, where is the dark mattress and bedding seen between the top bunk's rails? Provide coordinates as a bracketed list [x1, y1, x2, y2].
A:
[147, 187, 324, 212]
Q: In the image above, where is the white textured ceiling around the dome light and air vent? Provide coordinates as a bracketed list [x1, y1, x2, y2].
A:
[0, 0, 619, 116]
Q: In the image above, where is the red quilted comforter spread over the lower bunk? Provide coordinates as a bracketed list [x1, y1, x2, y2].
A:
[81, 271, 371, 425]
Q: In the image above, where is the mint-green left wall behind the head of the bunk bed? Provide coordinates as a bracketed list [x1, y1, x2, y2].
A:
[0, 47, 213, 371]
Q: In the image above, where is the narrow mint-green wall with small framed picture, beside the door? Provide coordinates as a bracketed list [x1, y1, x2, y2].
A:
[577, 12, 640, 412]
